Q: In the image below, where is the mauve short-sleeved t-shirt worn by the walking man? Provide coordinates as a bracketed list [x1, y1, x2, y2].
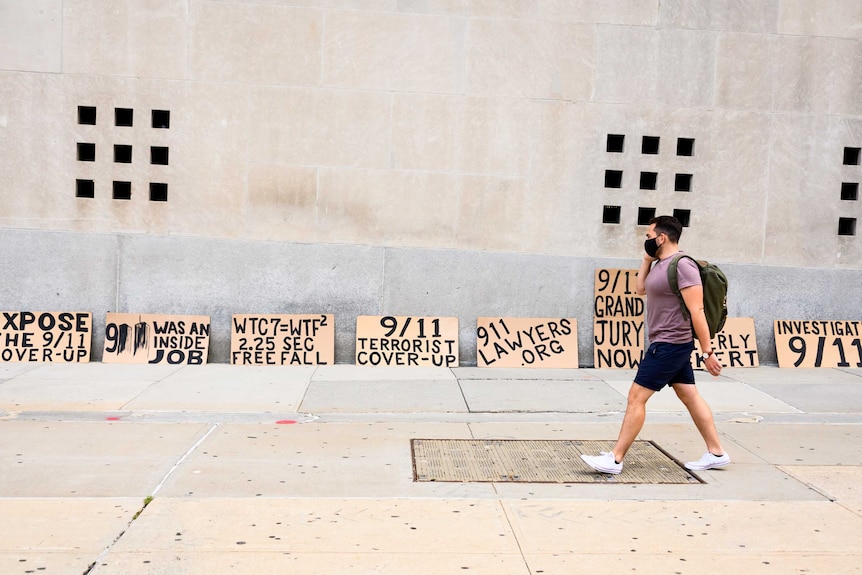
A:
[646, 252, 701, 343]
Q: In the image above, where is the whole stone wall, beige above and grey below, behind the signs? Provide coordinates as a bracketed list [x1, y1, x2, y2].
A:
[0, 0, 862, 363]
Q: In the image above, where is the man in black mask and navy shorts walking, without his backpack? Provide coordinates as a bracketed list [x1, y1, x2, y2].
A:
[581, 216, 730, 474]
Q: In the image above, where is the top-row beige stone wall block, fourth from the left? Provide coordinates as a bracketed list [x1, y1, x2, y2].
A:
[322, 10, 466, 93]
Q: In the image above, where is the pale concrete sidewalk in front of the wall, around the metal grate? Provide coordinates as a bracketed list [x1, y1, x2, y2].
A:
[0, 363, 862, 575]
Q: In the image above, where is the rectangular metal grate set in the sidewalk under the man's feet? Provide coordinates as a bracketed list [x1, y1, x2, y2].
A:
[411, 439, 703, 484]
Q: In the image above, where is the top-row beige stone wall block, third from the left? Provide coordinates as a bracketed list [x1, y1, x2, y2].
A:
[189, 2, 323, 86]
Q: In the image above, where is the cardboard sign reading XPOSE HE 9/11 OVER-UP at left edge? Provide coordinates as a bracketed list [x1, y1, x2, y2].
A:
[0, 311, 93, 363]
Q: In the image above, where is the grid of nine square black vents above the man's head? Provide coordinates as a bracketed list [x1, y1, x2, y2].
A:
[602, 134, 695, 227]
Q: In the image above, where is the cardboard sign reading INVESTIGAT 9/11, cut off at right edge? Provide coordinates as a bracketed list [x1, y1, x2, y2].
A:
[773, 320, 862, 367]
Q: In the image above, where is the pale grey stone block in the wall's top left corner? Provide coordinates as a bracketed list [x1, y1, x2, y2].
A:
[0, 0, 63, 73]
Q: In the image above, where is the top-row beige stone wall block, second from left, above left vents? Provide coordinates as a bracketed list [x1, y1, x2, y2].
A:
[63, 0, 189, 78]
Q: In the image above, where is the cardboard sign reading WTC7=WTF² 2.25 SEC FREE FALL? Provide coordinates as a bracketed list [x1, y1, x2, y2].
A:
[230, 314, 335, 365]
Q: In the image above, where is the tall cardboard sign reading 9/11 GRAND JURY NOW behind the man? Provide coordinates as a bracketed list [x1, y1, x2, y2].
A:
[593, 269, 646, 369]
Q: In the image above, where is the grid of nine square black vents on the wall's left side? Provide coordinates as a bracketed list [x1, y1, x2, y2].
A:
[75, 106, 171, 202]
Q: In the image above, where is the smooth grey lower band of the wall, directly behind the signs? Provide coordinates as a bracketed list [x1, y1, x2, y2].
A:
[0, 231, 862, 366]
